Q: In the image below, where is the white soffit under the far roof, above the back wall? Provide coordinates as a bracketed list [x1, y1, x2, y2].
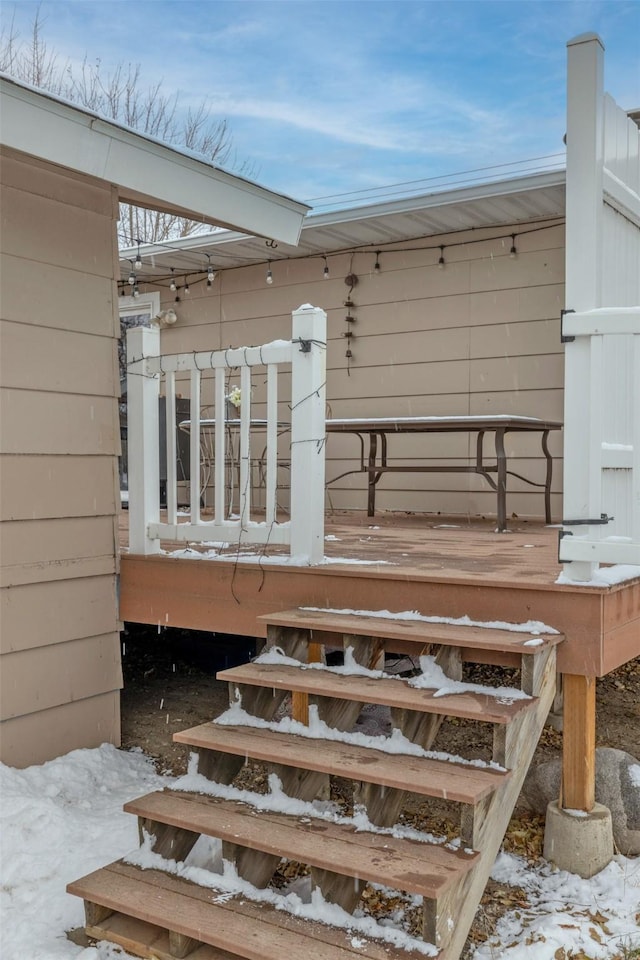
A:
[120, 170, 565, 279]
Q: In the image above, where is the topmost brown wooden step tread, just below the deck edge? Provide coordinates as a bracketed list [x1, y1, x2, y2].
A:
[257, 607, 564, 655]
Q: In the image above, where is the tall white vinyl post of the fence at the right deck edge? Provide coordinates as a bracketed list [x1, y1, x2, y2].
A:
[563, 34, 604, 580]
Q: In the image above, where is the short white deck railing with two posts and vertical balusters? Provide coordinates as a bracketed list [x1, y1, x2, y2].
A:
[127, 305, 326, 564]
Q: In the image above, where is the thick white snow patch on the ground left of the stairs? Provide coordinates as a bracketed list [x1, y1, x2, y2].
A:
[0, 744, 171, 960]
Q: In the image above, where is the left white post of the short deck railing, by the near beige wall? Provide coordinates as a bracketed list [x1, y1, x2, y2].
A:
[127, 327, 160, 554]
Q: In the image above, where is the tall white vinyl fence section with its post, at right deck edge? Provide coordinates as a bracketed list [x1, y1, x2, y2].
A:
[560, 35, 640, 580]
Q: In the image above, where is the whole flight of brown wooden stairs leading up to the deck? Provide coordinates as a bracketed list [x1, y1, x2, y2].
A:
[69, 609, 562, 960]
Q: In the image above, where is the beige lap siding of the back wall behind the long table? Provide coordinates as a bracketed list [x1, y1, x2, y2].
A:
[158, 221, 564, 518]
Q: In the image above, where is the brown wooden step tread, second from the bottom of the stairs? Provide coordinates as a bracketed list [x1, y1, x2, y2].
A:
[124, 790, 477, 899]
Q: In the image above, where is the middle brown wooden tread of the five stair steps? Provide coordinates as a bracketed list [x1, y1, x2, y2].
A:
[173, 723, 509, 804]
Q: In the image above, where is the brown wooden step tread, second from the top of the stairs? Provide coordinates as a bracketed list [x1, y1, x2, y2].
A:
[217, 663, 533, 723]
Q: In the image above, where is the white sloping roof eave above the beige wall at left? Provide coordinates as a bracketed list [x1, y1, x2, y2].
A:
[0, 75, 309, 244]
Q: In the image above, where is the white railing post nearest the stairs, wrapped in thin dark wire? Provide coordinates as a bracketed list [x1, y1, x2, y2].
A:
[291, 304, 327, 564]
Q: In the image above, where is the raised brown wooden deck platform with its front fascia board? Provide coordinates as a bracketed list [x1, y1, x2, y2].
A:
[120, 511, 640, 676]
